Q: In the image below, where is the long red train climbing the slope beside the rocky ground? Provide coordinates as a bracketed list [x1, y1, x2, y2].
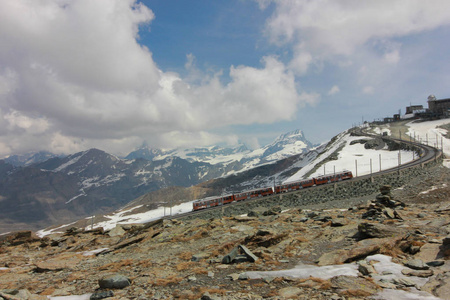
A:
[192, 171, 353, 211]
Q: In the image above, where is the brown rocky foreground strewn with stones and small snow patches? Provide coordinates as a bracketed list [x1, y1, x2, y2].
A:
[0, 167, 450, 300]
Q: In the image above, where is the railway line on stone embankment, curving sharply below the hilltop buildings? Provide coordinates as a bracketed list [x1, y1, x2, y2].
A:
[164, 128, 442, 219]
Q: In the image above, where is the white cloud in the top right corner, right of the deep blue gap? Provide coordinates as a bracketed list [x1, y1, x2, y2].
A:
[267, 0, 450, 56]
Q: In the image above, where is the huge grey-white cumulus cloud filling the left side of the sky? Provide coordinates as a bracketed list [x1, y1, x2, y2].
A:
[0, 0, 310, 156]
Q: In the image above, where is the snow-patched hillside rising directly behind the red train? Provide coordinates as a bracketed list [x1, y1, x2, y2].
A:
[33, 119, 450, 232]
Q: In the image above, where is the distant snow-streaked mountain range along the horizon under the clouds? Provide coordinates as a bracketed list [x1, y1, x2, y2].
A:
[0, 130, 314, 233]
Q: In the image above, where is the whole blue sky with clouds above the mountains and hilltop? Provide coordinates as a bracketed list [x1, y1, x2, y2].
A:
[0, 0, 450, 158]
